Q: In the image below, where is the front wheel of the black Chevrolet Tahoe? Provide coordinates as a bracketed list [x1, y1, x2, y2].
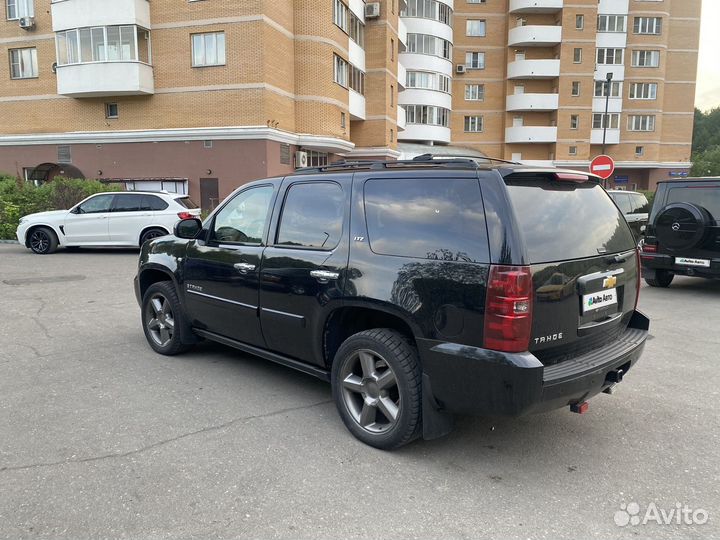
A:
[142, 281, 191, 356]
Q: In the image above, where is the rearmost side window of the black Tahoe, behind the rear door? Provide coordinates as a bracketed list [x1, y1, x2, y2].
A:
[365, 178, 490, 262]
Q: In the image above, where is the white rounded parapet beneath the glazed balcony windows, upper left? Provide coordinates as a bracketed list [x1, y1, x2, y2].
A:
[57, 61, 155, 97]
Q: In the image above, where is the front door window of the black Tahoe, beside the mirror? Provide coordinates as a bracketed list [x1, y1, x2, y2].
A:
[212, 186, 273, 244]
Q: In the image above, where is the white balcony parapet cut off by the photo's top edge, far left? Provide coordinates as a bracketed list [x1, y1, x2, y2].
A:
[51, 0, 150, 32]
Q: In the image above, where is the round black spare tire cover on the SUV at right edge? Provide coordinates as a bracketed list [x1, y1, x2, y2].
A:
[655, 203, 710, 251]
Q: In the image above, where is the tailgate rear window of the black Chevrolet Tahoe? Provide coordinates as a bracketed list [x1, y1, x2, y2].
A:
[505, 176, 635, 264]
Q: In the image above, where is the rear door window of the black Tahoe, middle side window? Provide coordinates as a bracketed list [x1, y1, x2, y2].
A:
[277, 182, 345, 249]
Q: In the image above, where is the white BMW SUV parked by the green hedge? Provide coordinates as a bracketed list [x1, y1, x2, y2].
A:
[17, 191, 200, 255]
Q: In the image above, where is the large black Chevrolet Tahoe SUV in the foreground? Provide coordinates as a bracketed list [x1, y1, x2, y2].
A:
[135, 155, 649, 449]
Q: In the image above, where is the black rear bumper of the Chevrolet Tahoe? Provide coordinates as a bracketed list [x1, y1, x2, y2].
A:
[418, 311, 650, 416]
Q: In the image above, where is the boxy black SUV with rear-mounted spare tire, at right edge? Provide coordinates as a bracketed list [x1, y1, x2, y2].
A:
[641, 178, 720, 287]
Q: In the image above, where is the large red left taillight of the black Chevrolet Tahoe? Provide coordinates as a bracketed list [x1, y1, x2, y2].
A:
[483, 265, 532, 352]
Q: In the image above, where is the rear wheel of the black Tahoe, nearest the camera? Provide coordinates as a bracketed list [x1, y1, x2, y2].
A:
[331, 328, 422, 450]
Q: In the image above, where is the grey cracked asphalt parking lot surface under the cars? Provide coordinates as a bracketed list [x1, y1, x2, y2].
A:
[0, 245, 720, 539]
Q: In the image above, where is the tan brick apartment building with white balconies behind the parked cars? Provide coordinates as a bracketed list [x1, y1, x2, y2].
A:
[0, 0, 700, 208]
